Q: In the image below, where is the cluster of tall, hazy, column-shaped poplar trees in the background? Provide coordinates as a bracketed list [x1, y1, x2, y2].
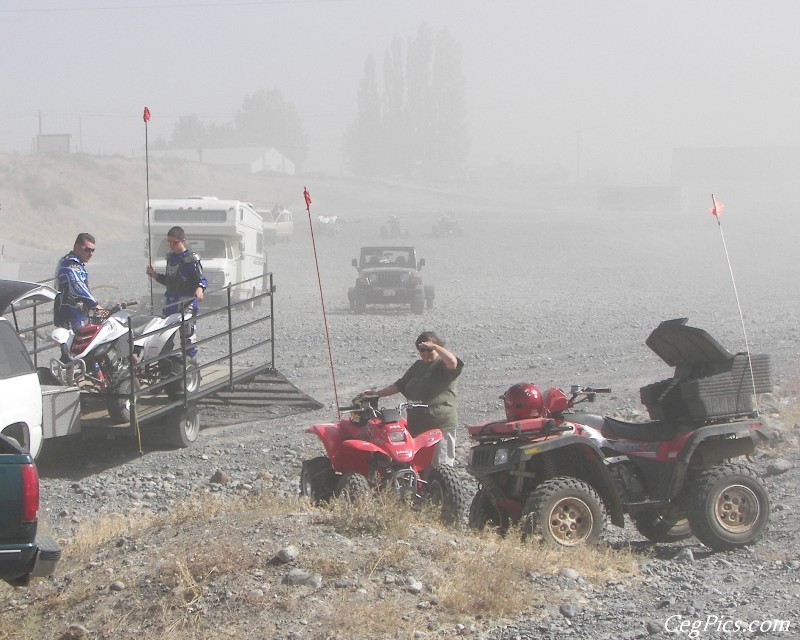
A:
[345, 25, 469, 178]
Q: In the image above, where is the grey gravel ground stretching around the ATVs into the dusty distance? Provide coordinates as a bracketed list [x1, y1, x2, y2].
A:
[0, 196, 800, 640]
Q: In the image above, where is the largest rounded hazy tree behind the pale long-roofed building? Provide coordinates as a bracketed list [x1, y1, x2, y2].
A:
[234, 89, 308, 166]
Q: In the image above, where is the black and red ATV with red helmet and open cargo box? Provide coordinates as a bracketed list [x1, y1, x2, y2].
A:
[467, 318, 772, 550]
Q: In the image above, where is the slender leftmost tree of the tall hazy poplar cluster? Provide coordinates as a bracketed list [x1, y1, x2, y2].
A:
[344, 56, 387, 176]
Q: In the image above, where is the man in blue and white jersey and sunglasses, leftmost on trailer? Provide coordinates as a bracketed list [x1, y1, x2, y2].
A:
[53, 233, 105, 331]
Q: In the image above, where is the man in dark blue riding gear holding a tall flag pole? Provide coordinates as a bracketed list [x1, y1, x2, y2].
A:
[145, 227, 208, 358]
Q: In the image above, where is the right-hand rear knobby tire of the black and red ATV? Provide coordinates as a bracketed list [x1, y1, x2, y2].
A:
[689, 463, 770, 551]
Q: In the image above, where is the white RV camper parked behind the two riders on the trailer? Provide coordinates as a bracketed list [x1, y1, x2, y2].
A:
[144, 197, 266, 302]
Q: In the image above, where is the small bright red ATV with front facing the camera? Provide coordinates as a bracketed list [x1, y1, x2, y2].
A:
[300, 395, 467, 524]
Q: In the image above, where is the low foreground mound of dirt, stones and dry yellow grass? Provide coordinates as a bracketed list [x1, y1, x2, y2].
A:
[0, 484, 636, 640]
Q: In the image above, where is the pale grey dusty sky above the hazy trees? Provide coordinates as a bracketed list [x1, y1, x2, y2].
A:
[0, 0, 800, 182]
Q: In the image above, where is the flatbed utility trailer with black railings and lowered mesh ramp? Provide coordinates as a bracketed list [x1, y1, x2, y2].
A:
[15, 273, 322, 447]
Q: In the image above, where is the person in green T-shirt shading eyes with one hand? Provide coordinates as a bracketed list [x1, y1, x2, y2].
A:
[364, 331, 464, 466]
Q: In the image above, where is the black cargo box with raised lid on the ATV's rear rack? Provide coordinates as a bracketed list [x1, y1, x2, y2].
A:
[640, 318, 772, 422]
